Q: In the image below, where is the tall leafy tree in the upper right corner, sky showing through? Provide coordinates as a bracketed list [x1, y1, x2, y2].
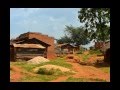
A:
[78, 8, 110, 42]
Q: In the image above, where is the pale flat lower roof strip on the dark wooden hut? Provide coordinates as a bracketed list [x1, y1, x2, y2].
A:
[13, 44, 45, 49]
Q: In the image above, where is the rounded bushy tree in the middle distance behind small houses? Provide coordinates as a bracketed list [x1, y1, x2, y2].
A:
[58, 25, 89, 46]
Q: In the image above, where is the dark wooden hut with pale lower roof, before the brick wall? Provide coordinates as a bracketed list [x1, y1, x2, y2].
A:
[10, 38, 50, 61]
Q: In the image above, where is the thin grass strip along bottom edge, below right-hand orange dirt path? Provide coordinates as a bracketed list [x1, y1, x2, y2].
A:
[64, 77, 106, 82]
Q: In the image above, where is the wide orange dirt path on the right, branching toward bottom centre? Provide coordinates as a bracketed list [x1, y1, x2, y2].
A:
[51, 62, 110, 82]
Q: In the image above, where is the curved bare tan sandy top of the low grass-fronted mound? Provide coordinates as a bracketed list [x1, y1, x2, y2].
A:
[33, 64, 75, 73]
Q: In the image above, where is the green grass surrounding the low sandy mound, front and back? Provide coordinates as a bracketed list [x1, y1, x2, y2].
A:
[10, 58, 73, 82]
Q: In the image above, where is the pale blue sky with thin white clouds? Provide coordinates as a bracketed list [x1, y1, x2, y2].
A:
[10, 8, 93, 47]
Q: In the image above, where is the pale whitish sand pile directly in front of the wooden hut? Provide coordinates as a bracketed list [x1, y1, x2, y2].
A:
[27, 56, 50, 64]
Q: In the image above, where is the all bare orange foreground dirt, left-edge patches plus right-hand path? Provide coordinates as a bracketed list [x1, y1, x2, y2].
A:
[10, 58, 110, 82]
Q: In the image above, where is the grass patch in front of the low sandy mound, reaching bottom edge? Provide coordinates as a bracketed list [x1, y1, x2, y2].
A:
[19, 69, 73, 82]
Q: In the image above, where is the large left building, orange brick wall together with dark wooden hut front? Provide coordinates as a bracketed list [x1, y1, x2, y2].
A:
[10, 32, 55, 61]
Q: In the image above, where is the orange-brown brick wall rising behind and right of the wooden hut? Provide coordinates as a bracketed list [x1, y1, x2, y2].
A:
[29, 33, 56, 59]
